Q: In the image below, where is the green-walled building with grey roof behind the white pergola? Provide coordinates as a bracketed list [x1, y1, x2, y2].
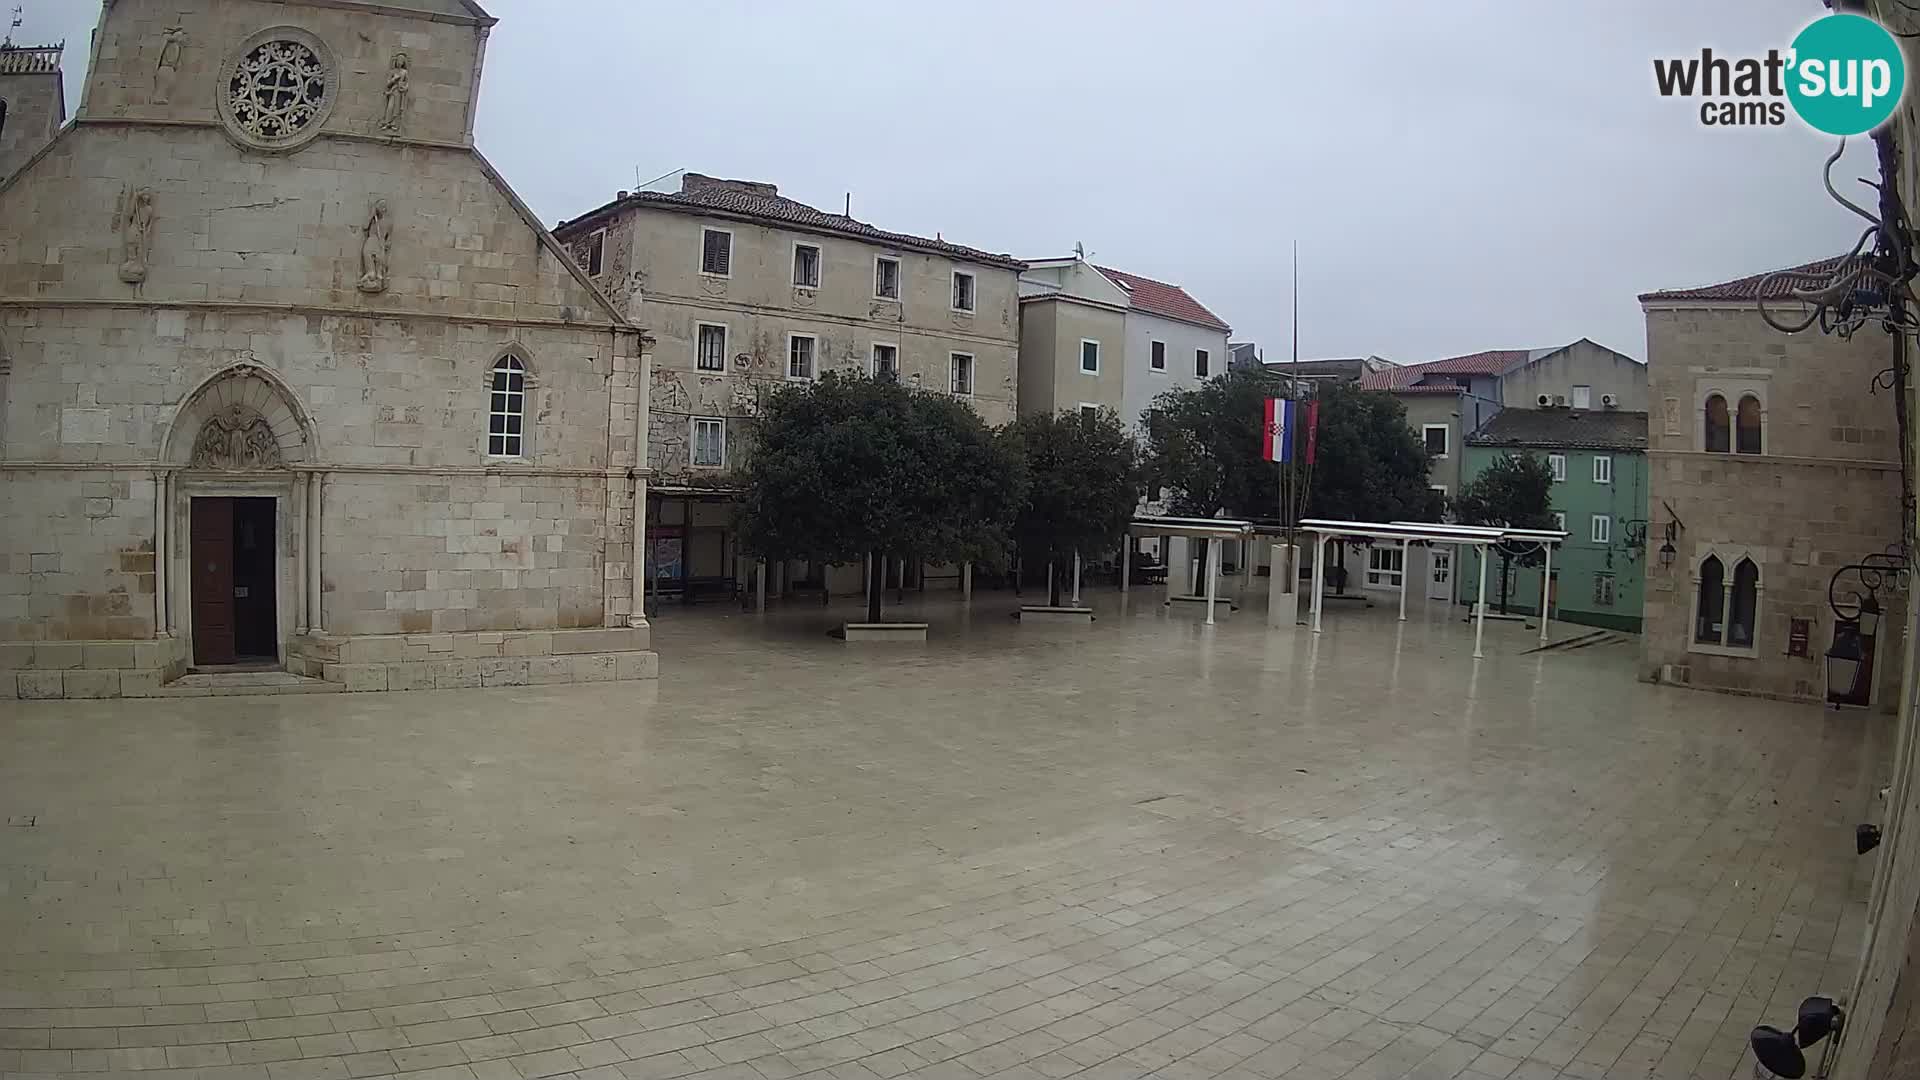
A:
[1455, 409, 1649, 632]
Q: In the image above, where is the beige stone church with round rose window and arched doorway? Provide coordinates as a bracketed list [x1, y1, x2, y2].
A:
[0, 0, 655, 698]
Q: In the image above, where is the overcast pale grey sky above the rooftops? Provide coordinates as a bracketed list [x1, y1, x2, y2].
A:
[37, 0, 1872, 363]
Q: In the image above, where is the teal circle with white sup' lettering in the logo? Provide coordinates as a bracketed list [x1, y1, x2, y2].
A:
[1788, 15, 1907, 135]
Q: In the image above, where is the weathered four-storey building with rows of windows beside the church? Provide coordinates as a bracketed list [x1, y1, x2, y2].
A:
[555, 173, 1023, 600]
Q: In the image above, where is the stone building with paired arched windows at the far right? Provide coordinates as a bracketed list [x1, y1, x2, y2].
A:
[1640, 259, 1905, 705]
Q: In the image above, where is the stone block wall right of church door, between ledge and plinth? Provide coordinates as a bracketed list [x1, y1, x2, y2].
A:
[321, 473, 607, 634]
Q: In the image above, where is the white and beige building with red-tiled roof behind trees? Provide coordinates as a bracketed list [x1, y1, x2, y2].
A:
[1020, 254, 1233, 425]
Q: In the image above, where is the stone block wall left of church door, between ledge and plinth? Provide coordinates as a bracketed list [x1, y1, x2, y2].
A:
[0, 465, 154, 642]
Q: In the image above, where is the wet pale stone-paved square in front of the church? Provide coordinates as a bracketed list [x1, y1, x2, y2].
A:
[0, 594, 1891, 1080]
